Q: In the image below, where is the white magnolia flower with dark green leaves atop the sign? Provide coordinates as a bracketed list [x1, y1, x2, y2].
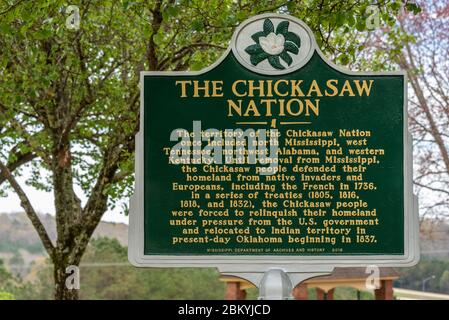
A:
[245, 19, 301, 70]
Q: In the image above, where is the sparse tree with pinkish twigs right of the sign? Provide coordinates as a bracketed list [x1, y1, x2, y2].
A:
[358, 0, 449, 225]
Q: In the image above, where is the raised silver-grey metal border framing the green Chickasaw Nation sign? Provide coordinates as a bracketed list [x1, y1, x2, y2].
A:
[128, 13, 420, 273]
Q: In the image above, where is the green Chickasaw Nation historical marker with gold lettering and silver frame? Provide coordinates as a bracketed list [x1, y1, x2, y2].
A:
[129, 14, 419, 272]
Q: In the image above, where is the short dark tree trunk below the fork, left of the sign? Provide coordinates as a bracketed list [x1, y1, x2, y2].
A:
[53, 254, 79, 300]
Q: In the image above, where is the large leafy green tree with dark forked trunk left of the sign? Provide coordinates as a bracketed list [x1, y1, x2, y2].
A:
[0, 0, 416, 299]
